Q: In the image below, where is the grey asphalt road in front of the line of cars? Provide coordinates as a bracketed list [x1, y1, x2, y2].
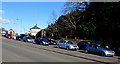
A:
[2, 38, 118, 63]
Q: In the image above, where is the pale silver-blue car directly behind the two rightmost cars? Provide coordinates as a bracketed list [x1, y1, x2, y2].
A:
[57, 40, 78, 50]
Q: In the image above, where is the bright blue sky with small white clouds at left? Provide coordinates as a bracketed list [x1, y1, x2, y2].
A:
[0, 2, 65, 33]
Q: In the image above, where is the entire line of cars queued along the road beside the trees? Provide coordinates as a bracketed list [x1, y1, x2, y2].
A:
[2, 34, 115, 56]
